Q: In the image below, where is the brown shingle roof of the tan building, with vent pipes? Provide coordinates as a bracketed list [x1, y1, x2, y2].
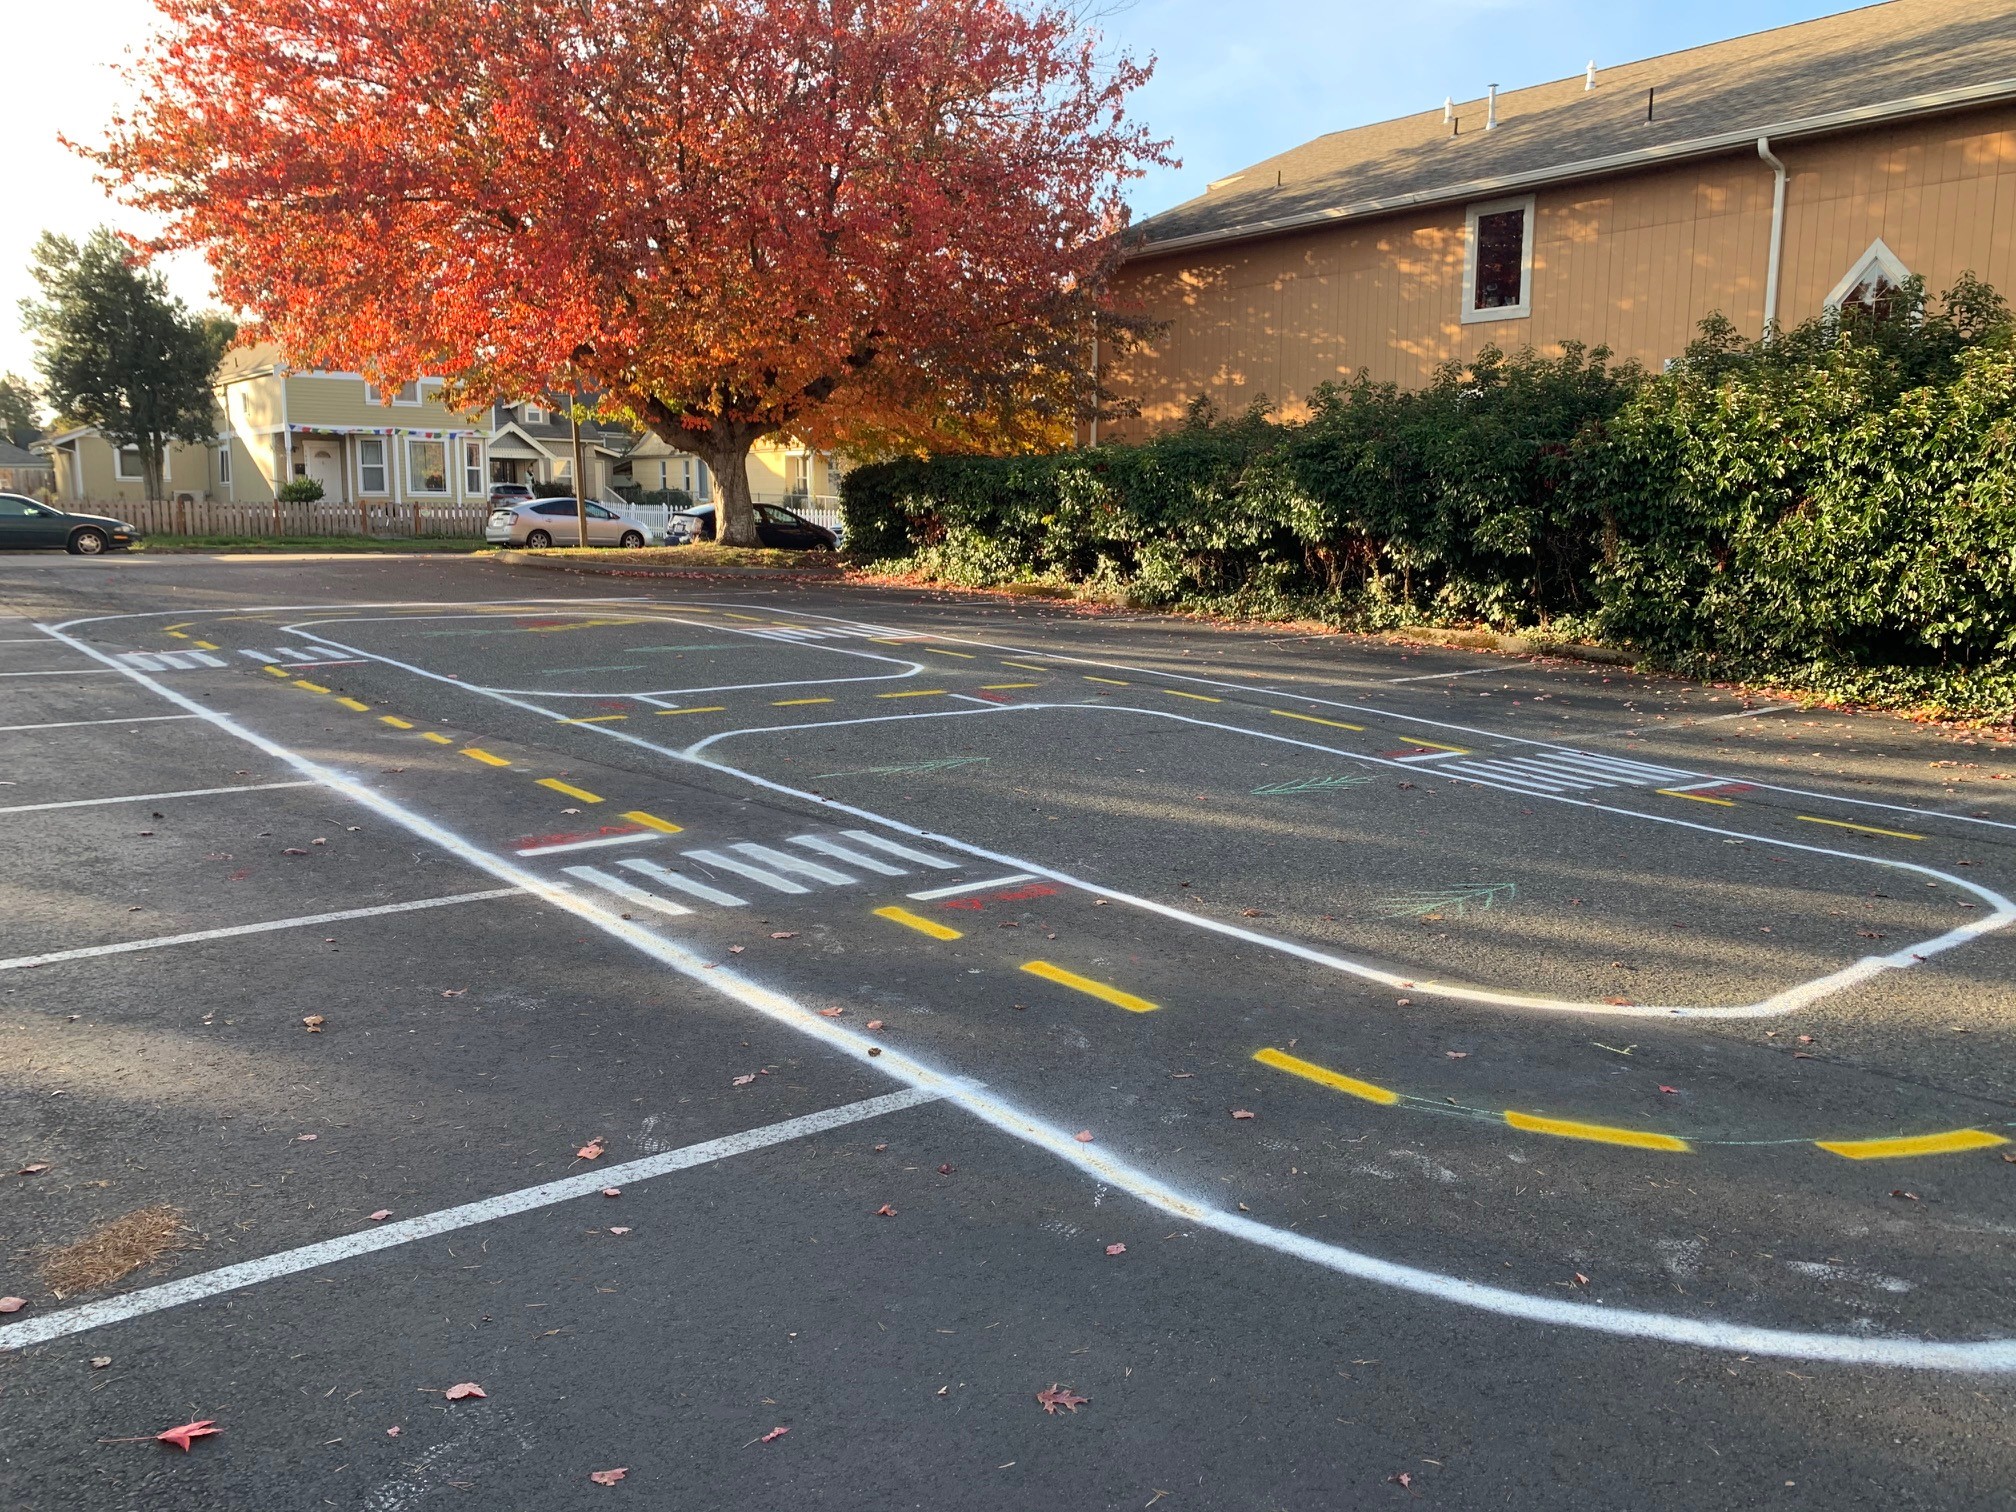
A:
[1129, 0, 2016, 254]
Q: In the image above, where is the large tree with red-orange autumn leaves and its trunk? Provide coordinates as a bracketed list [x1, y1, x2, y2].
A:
[95, 0, 1167, 544]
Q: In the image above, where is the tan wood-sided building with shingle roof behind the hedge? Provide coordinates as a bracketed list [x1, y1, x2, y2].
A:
[1112, 0, 2016, 439]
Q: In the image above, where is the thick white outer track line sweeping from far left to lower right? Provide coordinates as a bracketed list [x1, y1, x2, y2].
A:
[38, 627, 2016, 1373]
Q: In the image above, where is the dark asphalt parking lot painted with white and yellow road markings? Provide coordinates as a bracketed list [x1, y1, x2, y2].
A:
[0, 556, 2016, 1512]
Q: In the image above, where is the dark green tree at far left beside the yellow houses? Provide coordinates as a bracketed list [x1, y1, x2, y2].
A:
[22, 228, 236, 498]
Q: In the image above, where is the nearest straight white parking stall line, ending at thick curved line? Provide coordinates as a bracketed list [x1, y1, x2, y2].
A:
[0, 1087, 937, 1349]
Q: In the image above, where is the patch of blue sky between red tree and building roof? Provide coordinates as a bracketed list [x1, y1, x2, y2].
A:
[1095, 0, 1853, 218]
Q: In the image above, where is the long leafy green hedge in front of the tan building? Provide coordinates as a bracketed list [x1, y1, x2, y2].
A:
[843, 278, 2016, 720]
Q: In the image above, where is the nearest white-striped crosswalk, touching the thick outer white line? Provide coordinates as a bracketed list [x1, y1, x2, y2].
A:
[552, 829, 962, 917]
